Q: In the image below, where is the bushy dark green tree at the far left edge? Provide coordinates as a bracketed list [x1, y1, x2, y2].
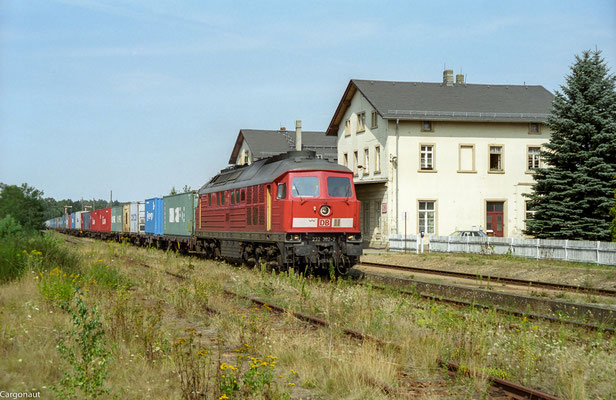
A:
[0, 183, 45, 230]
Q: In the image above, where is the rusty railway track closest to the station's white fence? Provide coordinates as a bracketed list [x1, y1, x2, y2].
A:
[359, 261, 616, 297]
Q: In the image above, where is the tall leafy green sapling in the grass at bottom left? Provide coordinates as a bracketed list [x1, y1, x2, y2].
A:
[52, 292, 112, 399]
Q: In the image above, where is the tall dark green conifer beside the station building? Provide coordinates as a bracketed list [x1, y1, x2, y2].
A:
[525, 50, 616, 241]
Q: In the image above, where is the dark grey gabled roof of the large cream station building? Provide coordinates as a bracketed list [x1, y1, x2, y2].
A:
[327, 79, 554, 135]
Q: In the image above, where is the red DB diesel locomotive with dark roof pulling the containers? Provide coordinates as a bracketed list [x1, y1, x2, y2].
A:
[194, 151, 362, 274]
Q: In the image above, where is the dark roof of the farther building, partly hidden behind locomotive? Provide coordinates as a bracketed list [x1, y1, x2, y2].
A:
[229, 129, 338, 164]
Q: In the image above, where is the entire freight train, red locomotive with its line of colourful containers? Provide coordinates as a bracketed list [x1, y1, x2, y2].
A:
[46, 151, 362, 275]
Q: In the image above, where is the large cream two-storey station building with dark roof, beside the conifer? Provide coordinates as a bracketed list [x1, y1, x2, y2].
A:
[326, 70, 554, 247]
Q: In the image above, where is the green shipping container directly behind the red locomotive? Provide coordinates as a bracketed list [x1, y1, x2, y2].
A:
[163, 192, 199, 236]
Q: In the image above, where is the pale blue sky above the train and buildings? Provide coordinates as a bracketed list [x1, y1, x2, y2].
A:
[0, 0, 616, 201]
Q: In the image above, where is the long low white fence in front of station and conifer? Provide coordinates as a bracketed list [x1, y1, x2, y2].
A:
[389, 235, 616, 265]
